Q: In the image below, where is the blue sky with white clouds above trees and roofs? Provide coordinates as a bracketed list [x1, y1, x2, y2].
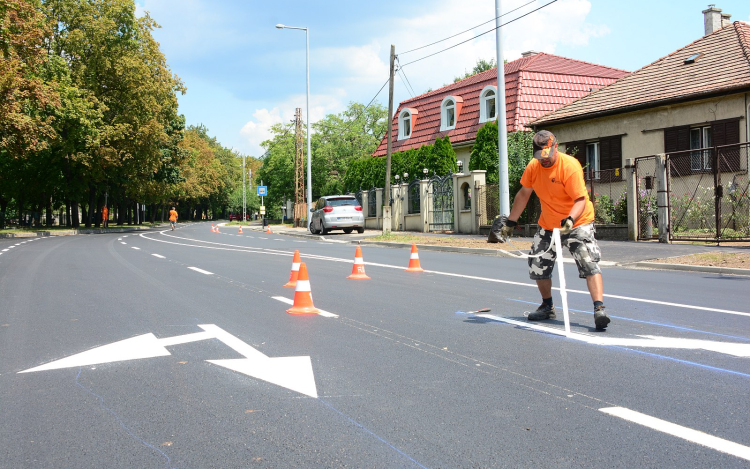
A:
[136, 0, 750, 157]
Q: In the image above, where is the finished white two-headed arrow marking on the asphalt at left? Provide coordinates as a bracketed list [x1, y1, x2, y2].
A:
[19, 324, 318, 398]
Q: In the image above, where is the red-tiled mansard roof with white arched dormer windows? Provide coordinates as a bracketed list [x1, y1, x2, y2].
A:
[373, 52, 628, 168]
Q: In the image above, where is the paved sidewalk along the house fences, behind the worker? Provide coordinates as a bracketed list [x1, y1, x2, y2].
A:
[242, 222, 750, 275]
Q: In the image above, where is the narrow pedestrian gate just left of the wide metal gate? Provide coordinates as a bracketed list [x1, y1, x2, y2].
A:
[635, 156, 659, 241]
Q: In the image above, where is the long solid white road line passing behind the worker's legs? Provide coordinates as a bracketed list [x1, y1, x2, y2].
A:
[140, 230, 750, 317]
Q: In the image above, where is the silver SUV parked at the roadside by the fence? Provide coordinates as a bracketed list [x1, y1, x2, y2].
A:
[310, 195, 365, 234]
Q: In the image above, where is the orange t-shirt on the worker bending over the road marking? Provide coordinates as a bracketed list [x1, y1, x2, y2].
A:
[521, 152, 594, 230]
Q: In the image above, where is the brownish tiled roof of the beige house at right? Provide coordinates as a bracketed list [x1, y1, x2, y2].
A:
[532, 21, 750, 126]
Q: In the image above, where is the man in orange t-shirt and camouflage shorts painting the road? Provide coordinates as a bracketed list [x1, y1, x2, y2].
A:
[502, 130, 610, 330]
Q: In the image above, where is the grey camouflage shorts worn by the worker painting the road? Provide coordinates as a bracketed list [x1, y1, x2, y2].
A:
[529, 223, 602, 280]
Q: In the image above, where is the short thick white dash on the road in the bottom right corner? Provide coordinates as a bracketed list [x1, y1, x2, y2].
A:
[599, 407, 750, 461]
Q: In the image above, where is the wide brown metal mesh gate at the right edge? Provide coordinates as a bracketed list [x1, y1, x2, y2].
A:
[667, 143, 750, 243]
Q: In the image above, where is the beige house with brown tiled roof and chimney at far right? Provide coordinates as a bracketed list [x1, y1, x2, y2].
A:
[528, 13, 750, 176]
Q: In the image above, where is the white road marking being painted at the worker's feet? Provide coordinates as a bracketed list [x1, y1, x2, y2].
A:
[475, 314, 750, 357]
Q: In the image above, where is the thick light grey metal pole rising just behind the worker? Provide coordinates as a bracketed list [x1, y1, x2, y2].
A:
[495, 0, 510, 215]
